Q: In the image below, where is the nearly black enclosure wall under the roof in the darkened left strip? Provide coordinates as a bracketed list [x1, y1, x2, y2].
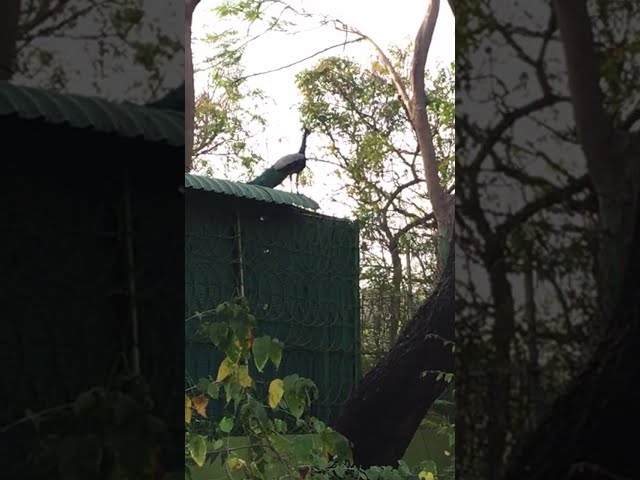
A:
[0, 122, 184, 472]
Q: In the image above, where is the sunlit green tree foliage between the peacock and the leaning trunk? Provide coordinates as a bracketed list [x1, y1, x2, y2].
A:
[296, 53, 454, 352]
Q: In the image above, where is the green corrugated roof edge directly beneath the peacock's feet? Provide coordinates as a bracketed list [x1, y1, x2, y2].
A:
[184, 173, 320, 210]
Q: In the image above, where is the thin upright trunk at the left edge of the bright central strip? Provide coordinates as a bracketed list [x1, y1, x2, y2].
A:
[184, 0, 200, 172]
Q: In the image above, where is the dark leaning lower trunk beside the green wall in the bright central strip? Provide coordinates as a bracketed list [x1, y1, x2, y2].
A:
[334, 242, 455, 467]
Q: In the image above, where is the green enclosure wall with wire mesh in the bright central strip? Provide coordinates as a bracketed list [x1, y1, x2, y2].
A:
[185, 190, 359, 422]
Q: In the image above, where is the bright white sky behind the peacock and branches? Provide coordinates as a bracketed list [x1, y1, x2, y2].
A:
[193, 0, 455, 216]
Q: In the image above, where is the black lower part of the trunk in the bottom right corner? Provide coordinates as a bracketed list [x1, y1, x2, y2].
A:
[504, 191, 640, 480]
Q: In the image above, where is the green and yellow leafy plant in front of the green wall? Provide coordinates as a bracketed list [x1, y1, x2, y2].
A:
[185, 298, 445, 480]
